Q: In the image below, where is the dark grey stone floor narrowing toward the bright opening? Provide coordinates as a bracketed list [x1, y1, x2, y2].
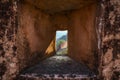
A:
[19, 55, 96, 80]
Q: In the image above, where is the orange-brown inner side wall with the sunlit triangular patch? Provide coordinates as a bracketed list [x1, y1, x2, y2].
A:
[17, 2, 55, 68]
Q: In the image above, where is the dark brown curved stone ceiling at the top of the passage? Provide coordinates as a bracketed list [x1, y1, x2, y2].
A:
[26, 0, 96, 13]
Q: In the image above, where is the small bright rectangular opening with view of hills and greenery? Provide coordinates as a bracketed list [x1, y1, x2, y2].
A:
[56, 30, 68, 55]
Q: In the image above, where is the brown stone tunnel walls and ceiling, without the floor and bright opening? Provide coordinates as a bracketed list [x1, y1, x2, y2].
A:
[0, 0, 120, 80]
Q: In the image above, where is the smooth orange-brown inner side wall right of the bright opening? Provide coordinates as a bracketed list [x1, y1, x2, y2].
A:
[68, 4, 97, 69]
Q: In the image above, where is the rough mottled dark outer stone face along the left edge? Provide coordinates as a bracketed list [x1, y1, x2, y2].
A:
[0, 0, 19, 80]
